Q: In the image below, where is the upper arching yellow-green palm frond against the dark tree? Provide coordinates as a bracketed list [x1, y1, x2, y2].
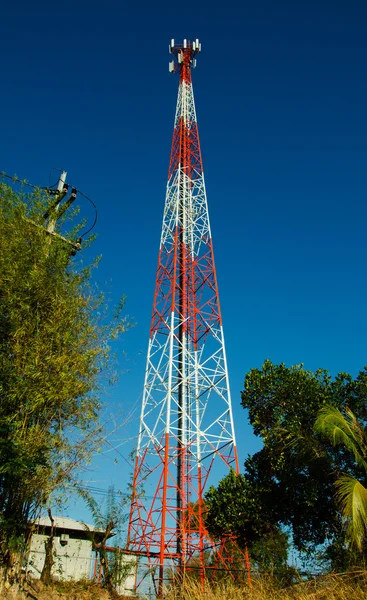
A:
[315, 406, 367, 472]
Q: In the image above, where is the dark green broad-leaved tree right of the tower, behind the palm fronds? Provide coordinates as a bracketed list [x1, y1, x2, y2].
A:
[206, 360, 367, 565]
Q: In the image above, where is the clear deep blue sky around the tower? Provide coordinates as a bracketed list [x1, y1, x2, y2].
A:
[0, 0, 367, 516]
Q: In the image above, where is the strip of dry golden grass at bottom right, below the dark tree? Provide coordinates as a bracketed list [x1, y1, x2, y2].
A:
[166, 572, 367, 600]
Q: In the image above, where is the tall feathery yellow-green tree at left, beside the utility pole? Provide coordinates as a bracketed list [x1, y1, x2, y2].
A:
[0, 183, 127, 569]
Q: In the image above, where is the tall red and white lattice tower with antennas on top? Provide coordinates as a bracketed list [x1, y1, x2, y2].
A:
[127, 40, 242, 597]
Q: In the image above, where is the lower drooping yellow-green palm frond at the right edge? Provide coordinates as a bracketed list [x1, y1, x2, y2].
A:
[335, 475, 367, 550]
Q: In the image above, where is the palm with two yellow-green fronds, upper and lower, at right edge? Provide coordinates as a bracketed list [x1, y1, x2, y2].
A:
[315, 406, 367, 551]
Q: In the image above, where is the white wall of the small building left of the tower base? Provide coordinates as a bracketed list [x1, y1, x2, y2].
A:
[28, 533, 93, 581]
